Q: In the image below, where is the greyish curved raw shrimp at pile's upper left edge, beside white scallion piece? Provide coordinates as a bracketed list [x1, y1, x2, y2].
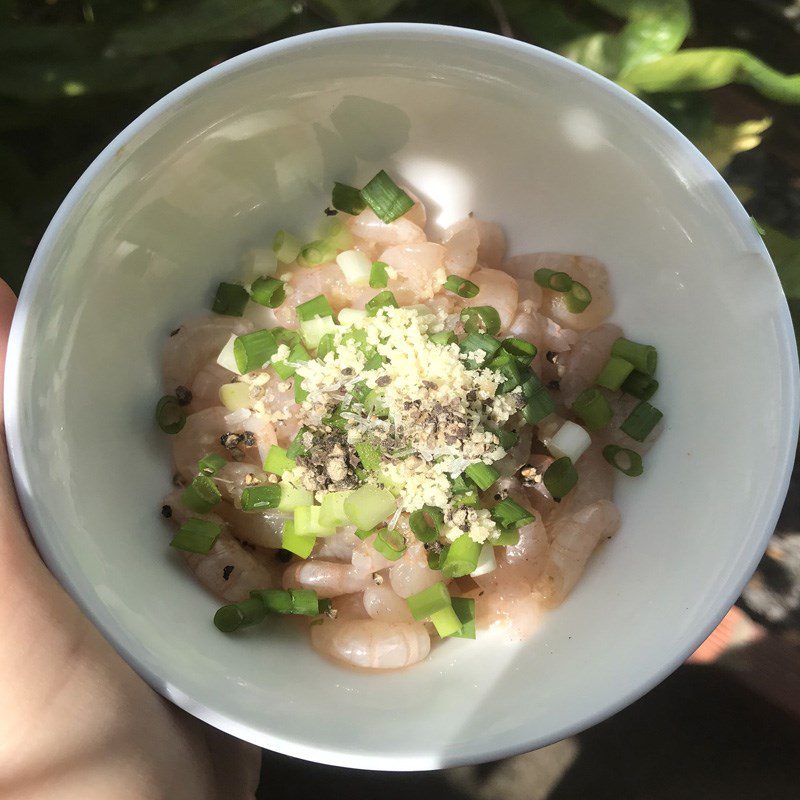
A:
[161, 314, 253, 394]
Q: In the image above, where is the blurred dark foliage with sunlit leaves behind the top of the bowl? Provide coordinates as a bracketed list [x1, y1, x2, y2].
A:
[0, 0, 800, 322]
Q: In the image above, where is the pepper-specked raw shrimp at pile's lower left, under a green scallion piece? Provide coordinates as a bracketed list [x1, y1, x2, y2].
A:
[164, 490, 283, 603]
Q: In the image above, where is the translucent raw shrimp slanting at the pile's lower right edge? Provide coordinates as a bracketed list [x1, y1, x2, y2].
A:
[534, 500, 620, 608]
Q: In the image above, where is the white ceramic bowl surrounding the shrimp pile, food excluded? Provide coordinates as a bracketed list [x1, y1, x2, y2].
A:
[6, 25, 798, 770]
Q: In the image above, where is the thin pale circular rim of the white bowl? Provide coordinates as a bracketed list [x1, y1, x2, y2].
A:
[4, 22, 800, 771]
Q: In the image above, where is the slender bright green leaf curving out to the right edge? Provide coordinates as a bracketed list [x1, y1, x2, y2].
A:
[620, 47, 800, 103]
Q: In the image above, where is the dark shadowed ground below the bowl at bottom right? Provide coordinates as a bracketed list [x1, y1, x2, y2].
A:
[258, 666, 800, 800]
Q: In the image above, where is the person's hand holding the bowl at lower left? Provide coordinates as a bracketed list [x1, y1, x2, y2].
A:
[0, 281, 261, 800]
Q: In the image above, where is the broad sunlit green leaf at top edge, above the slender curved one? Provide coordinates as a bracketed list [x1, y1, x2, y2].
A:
[561, 0, 692, 79]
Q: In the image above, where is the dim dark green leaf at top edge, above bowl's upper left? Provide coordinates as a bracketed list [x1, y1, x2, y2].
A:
[110, 0, 292, 56]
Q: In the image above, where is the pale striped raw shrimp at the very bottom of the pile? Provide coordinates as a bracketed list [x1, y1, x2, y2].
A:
[311, 619, 431, 669]
